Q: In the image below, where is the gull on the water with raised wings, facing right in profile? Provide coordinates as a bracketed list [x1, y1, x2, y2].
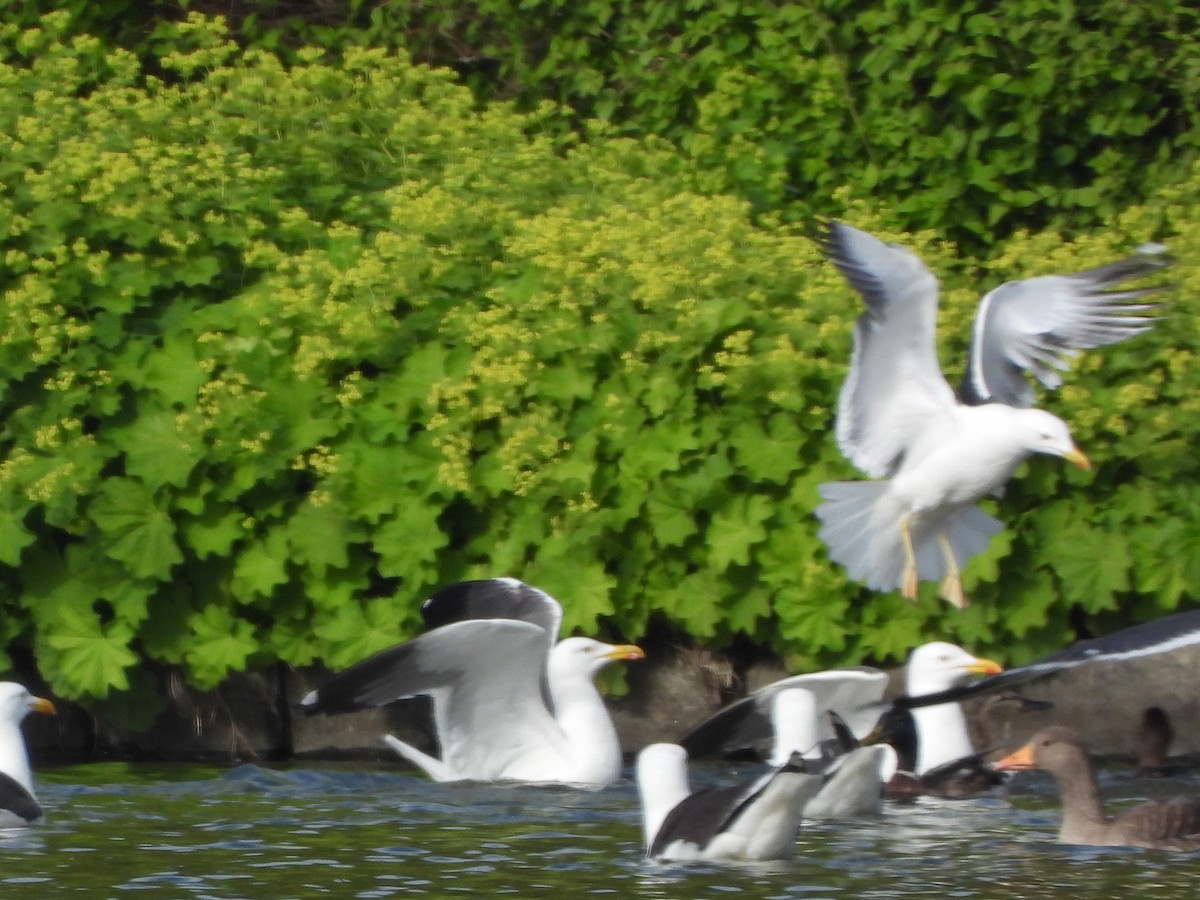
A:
[301, 578, 643, 788]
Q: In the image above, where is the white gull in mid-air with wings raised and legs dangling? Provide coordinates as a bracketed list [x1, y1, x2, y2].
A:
[816, 222, 1164, 607]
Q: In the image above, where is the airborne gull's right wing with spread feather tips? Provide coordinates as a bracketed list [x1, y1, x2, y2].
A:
[959, 251, 1168, 407]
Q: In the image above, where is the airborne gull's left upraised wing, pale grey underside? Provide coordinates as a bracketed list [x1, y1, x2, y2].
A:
[822, 222, 955, 478]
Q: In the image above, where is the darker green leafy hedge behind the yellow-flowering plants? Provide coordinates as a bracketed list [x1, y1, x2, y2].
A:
[9, 0, 1200, 248]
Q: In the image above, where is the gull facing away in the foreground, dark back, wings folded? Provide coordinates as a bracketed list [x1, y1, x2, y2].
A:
[637, 744, 822, 862]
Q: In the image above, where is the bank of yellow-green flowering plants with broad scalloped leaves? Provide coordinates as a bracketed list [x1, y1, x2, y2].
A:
[0, 16, 1200, 710]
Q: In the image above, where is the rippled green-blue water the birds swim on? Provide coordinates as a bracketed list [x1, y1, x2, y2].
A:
[0, 764, 1200, 900]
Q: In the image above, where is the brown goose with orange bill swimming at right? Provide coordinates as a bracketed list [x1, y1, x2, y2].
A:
[996, 727, 1200, 850]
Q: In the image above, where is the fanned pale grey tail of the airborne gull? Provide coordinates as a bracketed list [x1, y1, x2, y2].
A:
[816, 481, 1003, 592]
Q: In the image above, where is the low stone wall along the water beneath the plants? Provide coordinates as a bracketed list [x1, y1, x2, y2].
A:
[18, 647, 1200, 763]
